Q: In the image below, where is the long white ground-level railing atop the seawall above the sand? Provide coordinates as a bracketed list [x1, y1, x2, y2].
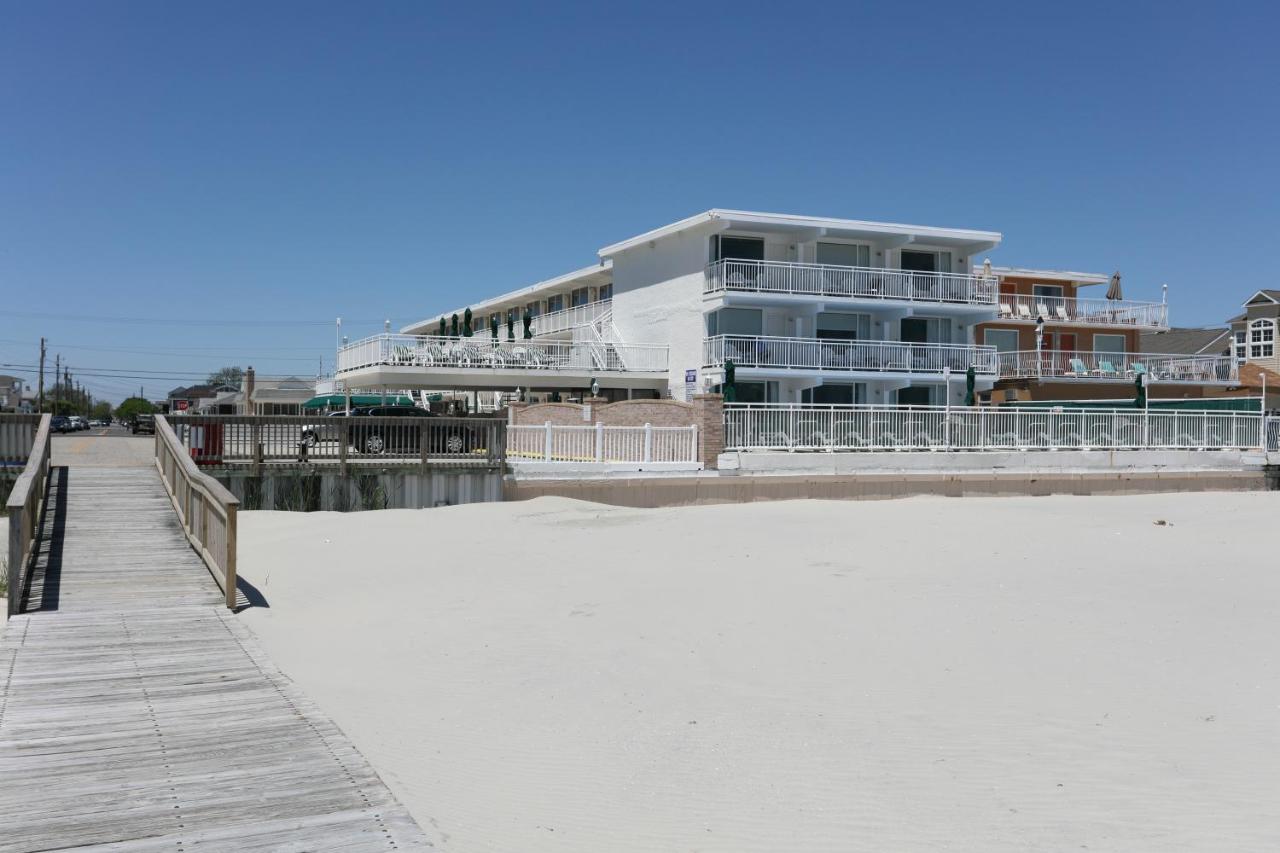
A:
[724, 403, 1265, 451]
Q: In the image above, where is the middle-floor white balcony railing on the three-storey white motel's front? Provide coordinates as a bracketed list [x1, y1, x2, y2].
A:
[703, 334, 996, 375]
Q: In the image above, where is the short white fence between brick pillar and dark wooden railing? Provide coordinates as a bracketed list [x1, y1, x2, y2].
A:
[507, 423, 700, 464]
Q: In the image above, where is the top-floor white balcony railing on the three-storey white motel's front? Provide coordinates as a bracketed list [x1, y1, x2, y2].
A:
[703, 260, 996, 305]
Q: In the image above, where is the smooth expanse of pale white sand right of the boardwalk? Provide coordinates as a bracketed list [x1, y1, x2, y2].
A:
[241, 493, 1280, 853]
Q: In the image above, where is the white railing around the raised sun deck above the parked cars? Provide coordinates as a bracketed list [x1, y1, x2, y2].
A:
[338, 334, 667, 374]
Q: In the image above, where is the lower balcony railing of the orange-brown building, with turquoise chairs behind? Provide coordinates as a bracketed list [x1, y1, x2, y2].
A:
[998, 350, 1236, 383]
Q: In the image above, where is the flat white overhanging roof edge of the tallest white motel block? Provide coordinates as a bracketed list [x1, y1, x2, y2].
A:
[599, 207, 1002, 257]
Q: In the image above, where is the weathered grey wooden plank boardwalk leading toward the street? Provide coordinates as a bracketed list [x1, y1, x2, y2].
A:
[0, 467, 431, 852]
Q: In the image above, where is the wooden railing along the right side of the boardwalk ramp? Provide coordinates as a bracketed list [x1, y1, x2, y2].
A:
[156, 415, 239, 608]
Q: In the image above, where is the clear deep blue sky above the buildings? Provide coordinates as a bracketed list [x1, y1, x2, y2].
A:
[0, 1, 1280, 400]
